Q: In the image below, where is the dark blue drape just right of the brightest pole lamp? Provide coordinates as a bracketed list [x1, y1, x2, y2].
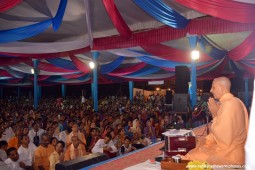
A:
[199, 36, 227, 60]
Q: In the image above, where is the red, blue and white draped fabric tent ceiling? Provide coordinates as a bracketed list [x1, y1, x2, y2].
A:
[0, 0, 255, 86]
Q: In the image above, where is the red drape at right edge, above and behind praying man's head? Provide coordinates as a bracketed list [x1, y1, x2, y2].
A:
[228, 31, 255, 61]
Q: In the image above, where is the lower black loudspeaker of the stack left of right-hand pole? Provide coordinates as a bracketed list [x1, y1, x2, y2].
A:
[174, 93, 189, 113]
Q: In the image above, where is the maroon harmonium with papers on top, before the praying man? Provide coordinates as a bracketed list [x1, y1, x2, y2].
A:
[162, 129, 196, 157]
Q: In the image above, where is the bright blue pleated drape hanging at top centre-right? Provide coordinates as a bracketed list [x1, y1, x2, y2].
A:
[133, 0, 189, 28]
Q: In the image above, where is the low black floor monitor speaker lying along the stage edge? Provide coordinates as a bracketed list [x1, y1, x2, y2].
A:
[55, 153, 108, 170]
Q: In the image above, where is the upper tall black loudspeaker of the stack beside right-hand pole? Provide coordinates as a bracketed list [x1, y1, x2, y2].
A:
[175, 66, 190, 93]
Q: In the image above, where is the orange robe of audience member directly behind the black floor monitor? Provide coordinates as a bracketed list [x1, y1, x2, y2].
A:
[64, 144, 86, 161]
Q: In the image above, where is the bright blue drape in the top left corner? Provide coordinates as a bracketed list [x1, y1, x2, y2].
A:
[0, 0, 67, 43]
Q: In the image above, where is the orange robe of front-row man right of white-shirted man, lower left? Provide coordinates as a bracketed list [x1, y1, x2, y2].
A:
[34, 145, 55, 170]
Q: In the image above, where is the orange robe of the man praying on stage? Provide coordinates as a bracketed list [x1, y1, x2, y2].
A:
[184, 93, 248, 165]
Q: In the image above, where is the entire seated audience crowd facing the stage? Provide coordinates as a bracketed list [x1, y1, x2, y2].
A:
[0, 96, 178, 170]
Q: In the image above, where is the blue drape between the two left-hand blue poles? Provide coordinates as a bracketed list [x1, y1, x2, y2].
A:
[47, 58, 79, 71]
